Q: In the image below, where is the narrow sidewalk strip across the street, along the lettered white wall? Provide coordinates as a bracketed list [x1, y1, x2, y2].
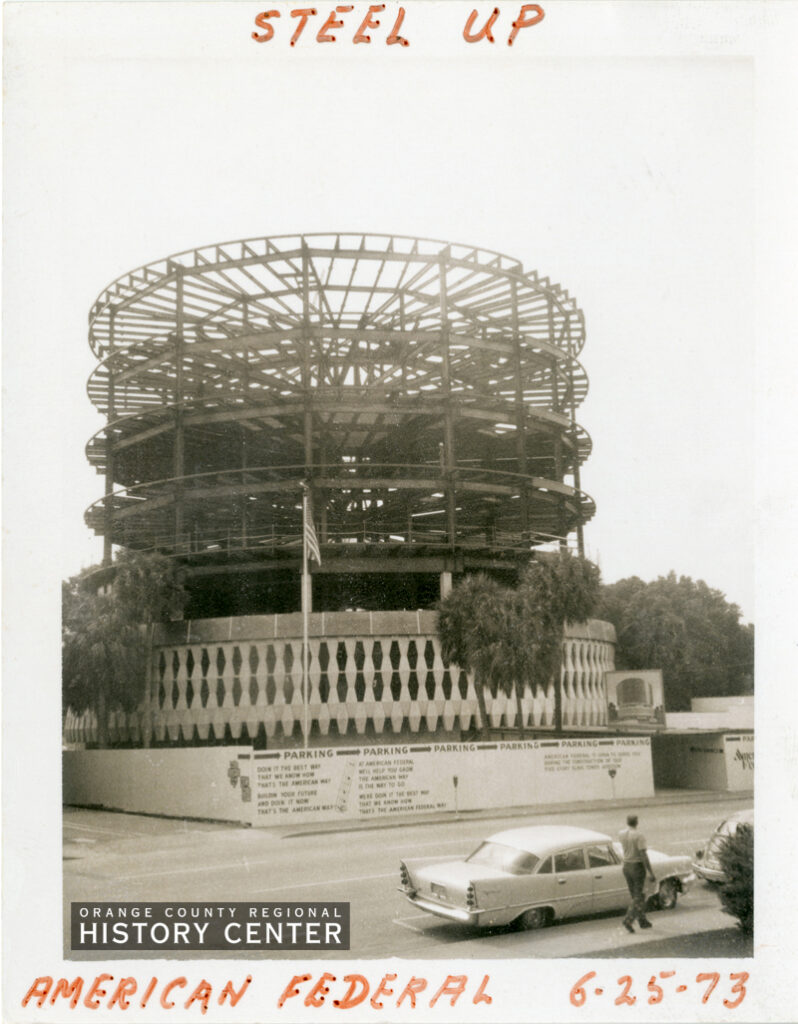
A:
[278, 790, 754, 839]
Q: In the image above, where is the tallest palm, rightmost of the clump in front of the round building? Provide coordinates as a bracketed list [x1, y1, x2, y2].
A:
[518, 549, 601, 732]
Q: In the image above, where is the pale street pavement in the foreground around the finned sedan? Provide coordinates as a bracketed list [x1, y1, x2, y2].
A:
[64, 791, 752, 959]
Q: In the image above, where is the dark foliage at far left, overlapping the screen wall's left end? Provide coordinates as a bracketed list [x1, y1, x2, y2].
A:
[61, 552, 184, 746]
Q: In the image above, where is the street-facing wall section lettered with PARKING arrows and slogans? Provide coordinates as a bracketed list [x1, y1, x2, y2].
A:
[250, 736, 654, 826]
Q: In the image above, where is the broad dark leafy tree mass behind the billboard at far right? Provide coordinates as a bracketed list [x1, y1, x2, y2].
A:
[598, 572, 754, 711]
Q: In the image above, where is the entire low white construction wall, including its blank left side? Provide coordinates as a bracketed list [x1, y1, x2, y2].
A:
[64, 737, 654, 827]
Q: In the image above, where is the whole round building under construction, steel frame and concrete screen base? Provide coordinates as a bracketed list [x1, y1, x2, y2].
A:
[73, 234, 612, 743]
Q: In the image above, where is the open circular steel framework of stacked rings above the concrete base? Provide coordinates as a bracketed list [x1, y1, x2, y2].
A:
[86, 234, 594, 606]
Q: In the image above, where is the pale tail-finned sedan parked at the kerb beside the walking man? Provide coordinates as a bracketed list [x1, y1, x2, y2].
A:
[398, 825, 696, 928]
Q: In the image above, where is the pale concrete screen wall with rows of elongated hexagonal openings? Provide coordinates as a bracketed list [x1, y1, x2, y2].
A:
[65, 611, 615, 749]
